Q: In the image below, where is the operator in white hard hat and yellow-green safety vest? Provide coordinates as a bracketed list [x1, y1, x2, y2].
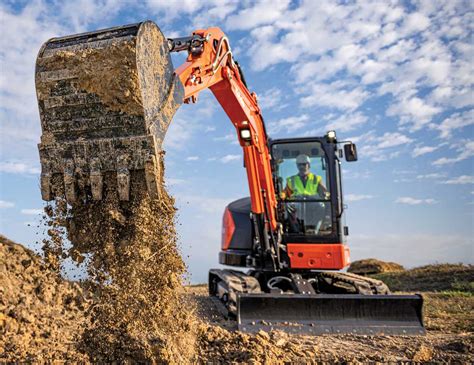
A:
[284, 154, 328, 199]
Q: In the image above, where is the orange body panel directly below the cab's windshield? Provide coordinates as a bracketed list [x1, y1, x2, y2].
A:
[287, 243, 350, 270]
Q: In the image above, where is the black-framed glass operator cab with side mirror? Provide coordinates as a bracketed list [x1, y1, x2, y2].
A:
[270, 132, 357, 243]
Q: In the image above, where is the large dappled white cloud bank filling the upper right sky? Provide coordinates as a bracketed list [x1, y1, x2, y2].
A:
[233, 1, 473, 133]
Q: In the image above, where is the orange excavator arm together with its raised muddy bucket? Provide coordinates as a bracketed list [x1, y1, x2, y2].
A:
[36, 21, 277, 229]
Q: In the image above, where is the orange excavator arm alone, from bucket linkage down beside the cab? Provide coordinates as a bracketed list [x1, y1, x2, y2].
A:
[169, 28, 277, 229]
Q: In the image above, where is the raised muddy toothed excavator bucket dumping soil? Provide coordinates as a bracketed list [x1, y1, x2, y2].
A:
[35, 21, 184, 204]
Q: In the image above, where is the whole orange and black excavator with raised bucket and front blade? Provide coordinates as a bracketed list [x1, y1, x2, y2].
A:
[35, 21, 425, 335]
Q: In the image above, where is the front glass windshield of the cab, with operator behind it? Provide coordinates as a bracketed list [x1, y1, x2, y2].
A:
[272, 141, 332, 236]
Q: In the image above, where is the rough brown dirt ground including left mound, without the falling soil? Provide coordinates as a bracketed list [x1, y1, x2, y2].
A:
[0, 236, 474, 364]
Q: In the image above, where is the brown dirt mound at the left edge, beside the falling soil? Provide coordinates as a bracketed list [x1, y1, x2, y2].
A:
[0, 235, 88, 363]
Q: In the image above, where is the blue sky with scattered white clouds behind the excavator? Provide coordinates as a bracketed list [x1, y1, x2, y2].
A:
[0, 0, 474, 283]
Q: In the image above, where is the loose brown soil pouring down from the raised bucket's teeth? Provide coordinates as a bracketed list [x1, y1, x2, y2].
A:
[45, 172, 195, 363]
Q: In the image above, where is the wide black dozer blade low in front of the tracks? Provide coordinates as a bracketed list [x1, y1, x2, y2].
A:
[237, 294, 425, 335]
